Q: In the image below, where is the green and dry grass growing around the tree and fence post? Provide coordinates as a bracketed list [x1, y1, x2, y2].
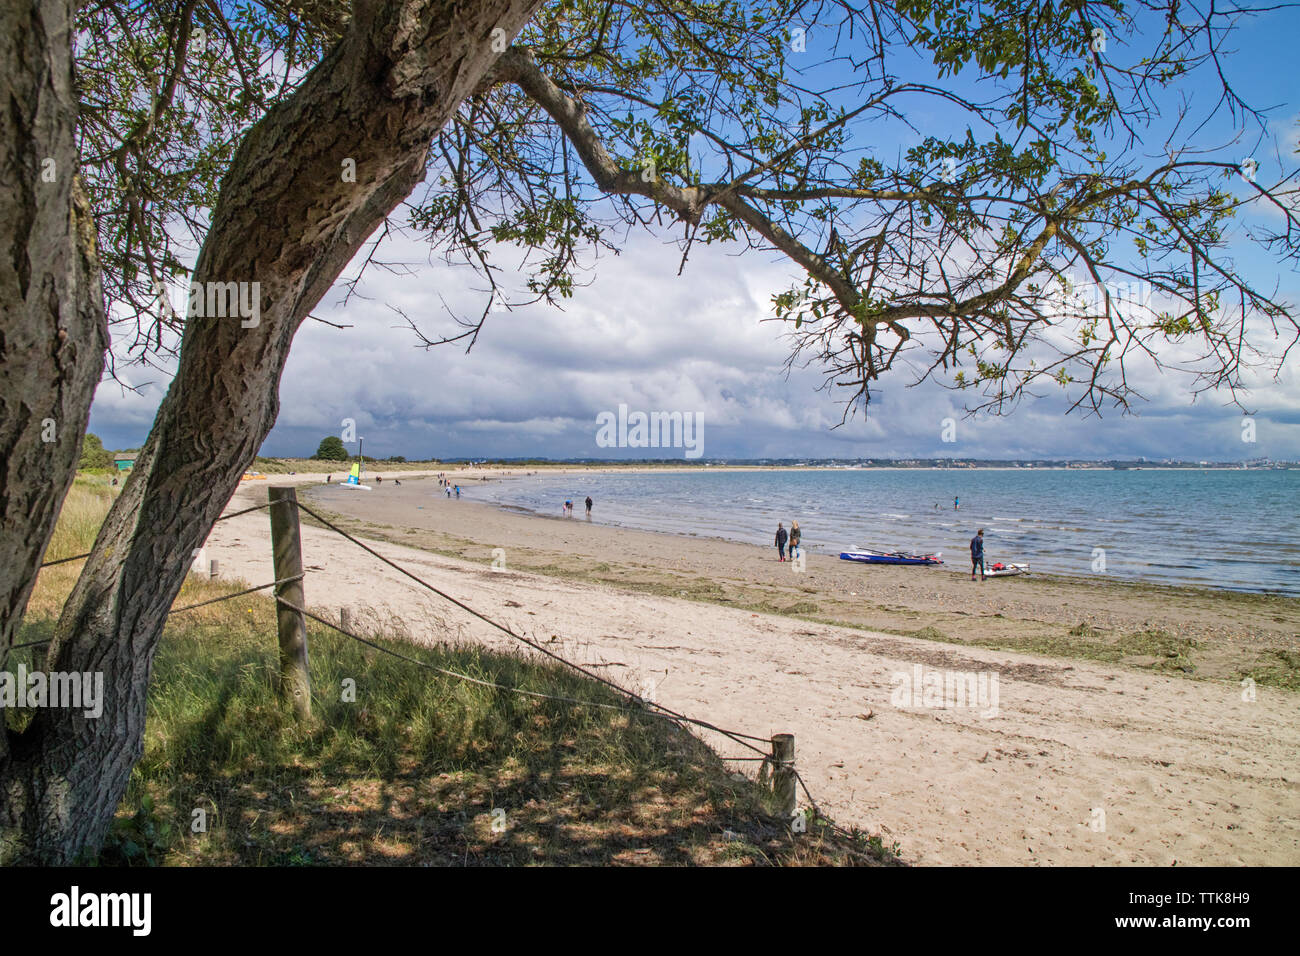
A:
[5, 473, 898, 865]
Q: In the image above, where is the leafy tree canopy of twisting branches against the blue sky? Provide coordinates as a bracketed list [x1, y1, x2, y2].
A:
[78, 0, 1300, 411]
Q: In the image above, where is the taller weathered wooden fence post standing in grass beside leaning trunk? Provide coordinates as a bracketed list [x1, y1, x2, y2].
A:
[267, 486, 312, 721]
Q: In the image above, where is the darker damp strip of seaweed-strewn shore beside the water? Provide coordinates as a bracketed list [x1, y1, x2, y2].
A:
[292, 473, 1300, 688]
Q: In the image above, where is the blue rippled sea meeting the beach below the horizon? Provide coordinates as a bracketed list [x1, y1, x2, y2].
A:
[468, 468, 1300, 594]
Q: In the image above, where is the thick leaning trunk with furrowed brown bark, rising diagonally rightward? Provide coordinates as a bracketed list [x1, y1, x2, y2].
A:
[4, 0, 538, 862]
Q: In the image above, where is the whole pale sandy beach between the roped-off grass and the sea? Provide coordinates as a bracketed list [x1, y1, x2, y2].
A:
[207, 470, 1300, 865]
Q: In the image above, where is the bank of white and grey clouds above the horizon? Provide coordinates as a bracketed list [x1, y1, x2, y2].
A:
[90, 0, 1300, 460]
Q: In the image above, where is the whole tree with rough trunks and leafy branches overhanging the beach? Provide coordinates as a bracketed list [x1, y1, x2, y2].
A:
[0, 0, 1300, 861]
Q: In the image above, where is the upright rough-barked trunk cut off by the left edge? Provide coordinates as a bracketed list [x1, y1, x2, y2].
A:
[0, 0, 108, 806]
